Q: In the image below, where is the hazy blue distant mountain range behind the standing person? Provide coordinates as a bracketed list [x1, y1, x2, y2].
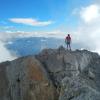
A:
[6, 37, 80, 56]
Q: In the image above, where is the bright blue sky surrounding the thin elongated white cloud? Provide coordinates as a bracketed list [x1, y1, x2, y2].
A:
[0, 0, 91, 31]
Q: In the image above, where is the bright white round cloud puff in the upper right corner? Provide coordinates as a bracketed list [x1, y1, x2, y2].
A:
[80, 4, 100, 23]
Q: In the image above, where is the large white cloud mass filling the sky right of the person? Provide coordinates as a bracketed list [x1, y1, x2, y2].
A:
[73, 4, 100, 54]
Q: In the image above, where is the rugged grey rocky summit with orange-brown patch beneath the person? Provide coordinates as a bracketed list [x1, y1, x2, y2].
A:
[0, 46, 100, 100]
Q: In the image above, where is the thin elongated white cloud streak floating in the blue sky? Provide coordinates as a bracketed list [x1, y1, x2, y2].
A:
[9, 18, 53, 26]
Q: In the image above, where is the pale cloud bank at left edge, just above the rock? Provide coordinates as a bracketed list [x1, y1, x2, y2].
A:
[0, 31, 17, 62]
